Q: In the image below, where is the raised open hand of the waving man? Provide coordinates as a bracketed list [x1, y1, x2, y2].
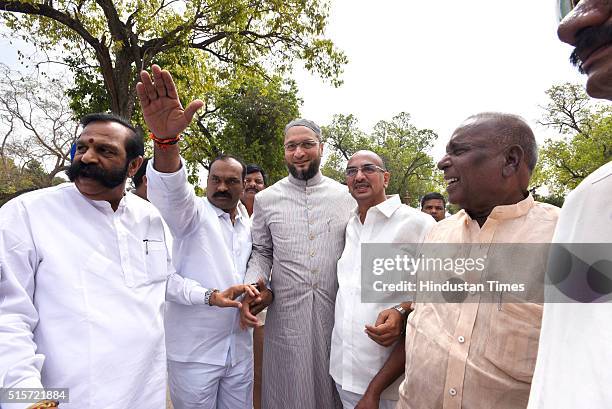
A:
[136, 65, 204, 139]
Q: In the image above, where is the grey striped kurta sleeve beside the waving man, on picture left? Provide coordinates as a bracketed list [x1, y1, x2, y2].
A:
[244, 195, 273, 287]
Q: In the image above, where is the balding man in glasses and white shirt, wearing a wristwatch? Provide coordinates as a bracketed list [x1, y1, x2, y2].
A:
[330, 151, 435, 409]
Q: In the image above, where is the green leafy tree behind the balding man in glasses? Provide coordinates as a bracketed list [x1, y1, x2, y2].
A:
[322, 112, 442, 206]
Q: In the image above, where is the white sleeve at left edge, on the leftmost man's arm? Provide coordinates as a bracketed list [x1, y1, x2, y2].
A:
[0, 201, 45, 409]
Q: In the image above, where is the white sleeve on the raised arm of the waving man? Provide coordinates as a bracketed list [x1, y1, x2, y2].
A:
[147, 158, 198, 238]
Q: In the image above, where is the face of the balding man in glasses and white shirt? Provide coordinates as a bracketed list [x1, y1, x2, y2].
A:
[346, 151, 390, 208]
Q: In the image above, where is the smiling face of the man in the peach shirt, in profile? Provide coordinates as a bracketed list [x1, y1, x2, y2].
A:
[438, 119, 504, 213]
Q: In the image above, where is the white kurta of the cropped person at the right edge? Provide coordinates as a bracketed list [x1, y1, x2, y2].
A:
[528, 162, 612, 409]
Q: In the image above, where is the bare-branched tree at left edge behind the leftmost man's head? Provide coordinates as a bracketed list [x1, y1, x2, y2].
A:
[0, 64, 77, 202]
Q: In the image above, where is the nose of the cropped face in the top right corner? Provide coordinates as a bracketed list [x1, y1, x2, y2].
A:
[557, 0, 612, 45]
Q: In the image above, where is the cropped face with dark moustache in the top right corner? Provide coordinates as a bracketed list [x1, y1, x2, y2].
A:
[557, 0, 612, 100]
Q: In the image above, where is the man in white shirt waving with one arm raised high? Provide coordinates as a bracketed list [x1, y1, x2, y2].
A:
[137, 65, 253, 409]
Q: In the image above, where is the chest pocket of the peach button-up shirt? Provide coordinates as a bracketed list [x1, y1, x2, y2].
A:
[485, 303, 542, 383]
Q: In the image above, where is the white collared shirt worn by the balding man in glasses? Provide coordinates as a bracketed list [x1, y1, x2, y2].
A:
[330, 195, 435, 399]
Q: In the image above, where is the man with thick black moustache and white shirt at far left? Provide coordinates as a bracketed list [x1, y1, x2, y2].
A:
[0, 114, 256, 409]
